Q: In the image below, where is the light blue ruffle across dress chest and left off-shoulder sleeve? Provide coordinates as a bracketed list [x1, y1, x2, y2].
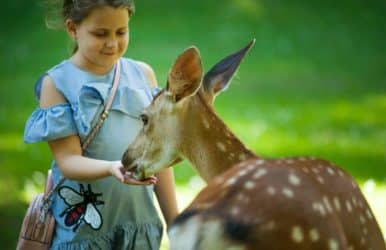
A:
[24, 82, 154, 143]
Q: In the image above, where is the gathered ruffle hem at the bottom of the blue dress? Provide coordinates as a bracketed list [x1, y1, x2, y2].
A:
[51, 223, 162, 250]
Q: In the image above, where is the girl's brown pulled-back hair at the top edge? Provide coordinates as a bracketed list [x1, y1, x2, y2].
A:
[46, 0, 135, 29]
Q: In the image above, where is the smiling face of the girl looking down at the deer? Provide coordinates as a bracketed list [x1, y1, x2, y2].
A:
[66, 6, 129, 74]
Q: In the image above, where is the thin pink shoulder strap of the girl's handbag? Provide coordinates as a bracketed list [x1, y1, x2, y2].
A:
[44, 60, 121, 201]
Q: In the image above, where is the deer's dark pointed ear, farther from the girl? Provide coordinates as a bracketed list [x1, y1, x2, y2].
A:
[203, 39, 256, 102]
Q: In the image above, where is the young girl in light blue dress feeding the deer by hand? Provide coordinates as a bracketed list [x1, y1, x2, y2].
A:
[24, 0, 177, 250]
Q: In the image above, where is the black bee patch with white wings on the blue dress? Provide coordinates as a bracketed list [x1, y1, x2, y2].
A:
[58, 184, 104, 232]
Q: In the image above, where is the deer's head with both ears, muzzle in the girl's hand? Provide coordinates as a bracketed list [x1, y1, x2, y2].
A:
[122, 40, 255, 179]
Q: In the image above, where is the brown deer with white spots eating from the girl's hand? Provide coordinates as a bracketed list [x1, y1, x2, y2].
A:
[122, 39, 386, 250]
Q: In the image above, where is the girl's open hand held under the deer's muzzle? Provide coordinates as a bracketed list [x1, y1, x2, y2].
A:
[110, 161, 157, 185]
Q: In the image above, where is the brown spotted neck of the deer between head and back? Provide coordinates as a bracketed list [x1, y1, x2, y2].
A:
[182, 95, 257, 182]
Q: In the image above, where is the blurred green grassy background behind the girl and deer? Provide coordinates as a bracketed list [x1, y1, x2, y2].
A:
[0, 0, 386, 249]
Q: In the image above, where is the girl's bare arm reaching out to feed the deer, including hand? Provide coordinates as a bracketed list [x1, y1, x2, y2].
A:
[40, 76, 156, 184]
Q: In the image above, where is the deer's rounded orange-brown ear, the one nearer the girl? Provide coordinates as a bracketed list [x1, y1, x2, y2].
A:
[167, 47, 203, 102]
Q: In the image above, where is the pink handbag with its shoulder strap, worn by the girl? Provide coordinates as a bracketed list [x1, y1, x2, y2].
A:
[16, 61, 120, 250]
